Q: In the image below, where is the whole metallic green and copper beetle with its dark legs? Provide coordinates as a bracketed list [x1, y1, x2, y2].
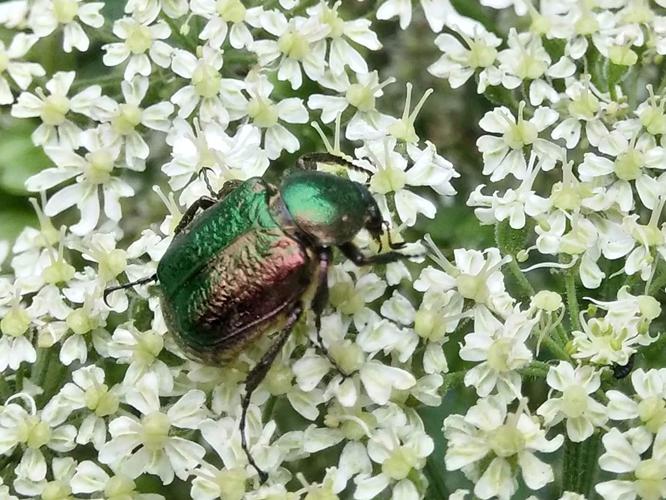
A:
[104, 153, 407, 482]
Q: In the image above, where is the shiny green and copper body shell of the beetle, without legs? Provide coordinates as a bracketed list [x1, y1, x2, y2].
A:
[157, 172, 374, 364]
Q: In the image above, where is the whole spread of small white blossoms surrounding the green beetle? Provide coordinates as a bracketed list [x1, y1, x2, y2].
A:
[0, 0, 666, 500]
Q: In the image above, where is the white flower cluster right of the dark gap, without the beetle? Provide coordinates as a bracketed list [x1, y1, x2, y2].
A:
[429, 0, 666, 499]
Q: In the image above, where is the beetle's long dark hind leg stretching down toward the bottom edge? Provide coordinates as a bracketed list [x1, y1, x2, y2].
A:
[239, 304, 303, 483]
